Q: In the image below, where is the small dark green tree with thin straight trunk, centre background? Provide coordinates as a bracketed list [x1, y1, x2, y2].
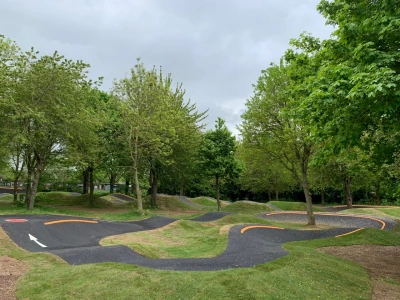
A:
[200, 118, 238, 211]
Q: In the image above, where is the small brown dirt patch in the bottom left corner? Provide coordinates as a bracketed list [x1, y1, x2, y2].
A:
[0, 256, 28, 300]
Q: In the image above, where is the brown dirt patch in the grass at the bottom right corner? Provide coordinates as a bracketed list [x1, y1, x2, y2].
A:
[320, 245, 400, 300]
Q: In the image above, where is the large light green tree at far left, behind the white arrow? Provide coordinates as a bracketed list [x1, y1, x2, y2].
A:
[0, 49, 99, 209]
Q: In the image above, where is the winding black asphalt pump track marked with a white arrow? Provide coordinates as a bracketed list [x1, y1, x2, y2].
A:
[0, 213, 394, 271]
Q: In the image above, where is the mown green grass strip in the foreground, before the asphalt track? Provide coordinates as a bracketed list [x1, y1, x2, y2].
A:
[0, 221, 400, 300]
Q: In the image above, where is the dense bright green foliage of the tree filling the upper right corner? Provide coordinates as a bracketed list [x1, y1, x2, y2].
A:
[303, 0, 400, 159]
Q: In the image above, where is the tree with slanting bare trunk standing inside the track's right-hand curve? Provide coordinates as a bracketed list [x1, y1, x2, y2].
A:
[240, 61, 316, 225]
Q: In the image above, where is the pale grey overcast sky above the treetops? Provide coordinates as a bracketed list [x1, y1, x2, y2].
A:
[0, 0, 332, 133]
